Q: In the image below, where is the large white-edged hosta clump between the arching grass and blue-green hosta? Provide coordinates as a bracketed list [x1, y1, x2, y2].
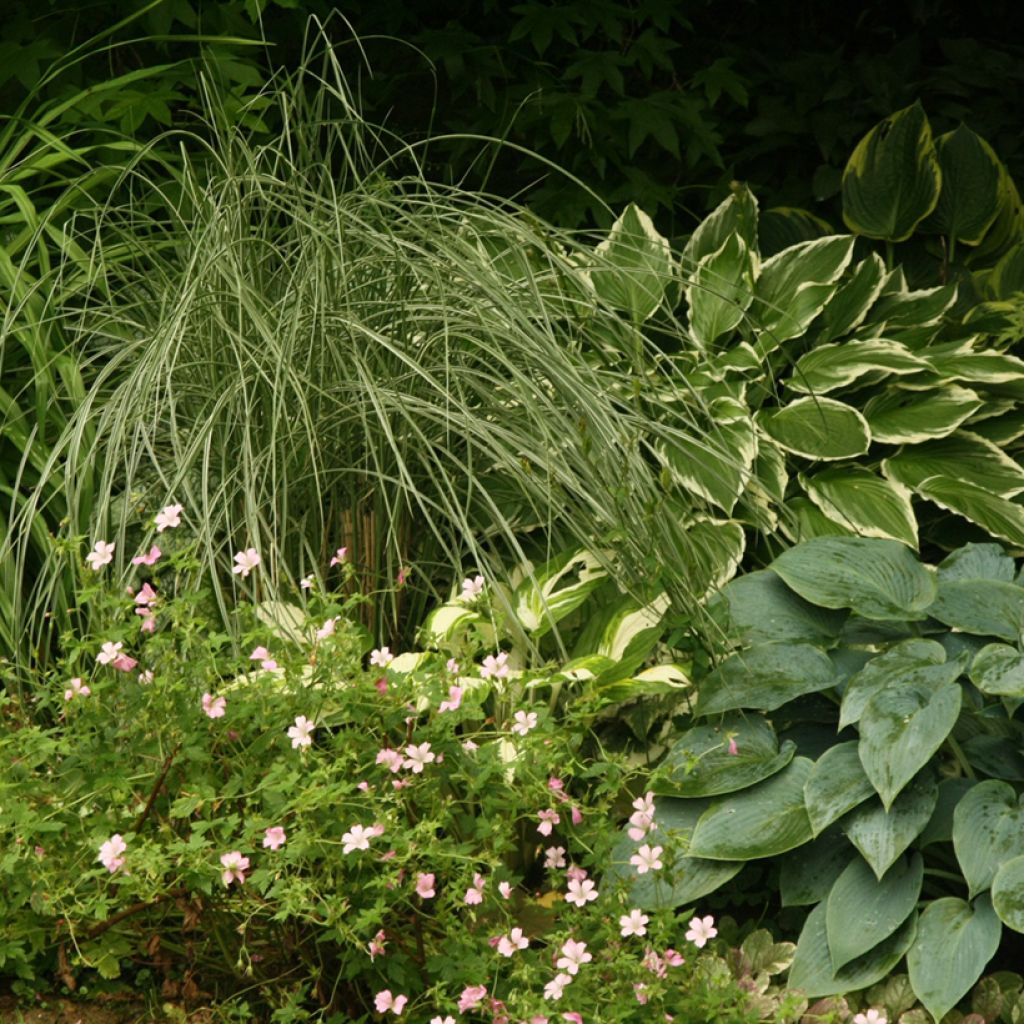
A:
[588, 185, 1024, 564]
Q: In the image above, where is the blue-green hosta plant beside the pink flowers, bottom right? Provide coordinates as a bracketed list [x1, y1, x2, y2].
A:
[612, 537, 1024, 1021]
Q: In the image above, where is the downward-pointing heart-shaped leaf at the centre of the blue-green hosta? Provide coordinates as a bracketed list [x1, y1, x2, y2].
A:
[858, 682, 963, 810]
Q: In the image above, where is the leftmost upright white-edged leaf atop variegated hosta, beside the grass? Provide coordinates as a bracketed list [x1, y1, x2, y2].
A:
[590, 203, 675, 324]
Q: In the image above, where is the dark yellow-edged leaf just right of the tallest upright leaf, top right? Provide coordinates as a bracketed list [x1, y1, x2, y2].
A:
[921, 124, 1001, 246]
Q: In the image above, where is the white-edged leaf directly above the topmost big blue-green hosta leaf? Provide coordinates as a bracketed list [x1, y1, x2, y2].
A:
[799, 466, 918, 551]
